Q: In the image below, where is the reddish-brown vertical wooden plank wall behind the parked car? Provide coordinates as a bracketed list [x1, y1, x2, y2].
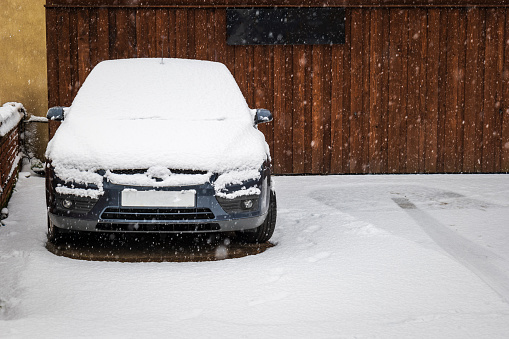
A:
[47, 7, 509, 174]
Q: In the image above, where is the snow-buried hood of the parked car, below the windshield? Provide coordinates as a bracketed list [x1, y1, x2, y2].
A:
[46, 117, 269, 173]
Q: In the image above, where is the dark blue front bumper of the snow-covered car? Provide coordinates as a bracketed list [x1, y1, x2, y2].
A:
[48, 177, 270, 233]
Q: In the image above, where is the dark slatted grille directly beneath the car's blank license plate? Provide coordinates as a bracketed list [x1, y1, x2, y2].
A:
[101, 207, 215, 221]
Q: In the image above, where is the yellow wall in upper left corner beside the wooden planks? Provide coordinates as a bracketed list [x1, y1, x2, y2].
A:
[0, 0, 48, 158]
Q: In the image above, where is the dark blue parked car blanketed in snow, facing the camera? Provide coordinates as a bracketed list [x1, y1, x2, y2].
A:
[46, 59, 276, 242]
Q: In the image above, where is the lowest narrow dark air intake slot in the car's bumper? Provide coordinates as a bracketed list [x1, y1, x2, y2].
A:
[96, 223, 221, 232]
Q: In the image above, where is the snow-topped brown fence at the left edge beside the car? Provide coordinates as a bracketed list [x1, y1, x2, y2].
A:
[0, 102, 26, 209]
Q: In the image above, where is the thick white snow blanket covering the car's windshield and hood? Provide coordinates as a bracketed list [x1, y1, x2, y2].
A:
[46, 59, 269, 173]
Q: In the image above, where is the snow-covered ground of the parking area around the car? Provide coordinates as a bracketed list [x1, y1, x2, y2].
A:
[0, 175, 509, 338]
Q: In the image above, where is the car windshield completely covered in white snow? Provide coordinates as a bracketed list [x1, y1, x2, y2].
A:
[66, 59, 251, 121]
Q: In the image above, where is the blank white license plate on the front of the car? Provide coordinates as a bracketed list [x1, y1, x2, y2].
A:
[122, 190, 196, 207]
